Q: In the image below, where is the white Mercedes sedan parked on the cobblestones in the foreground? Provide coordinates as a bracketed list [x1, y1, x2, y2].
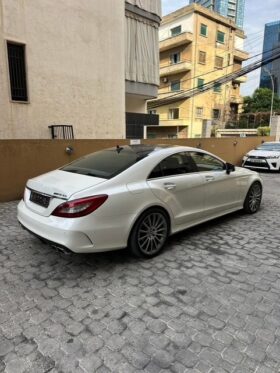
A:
[18, 145, 262, 257]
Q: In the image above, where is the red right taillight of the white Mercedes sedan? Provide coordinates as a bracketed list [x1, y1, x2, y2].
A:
[52, 194, 108, 218]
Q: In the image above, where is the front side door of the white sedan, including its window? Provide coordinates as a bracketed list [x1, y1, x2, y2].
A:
[189, 151, 240, 216]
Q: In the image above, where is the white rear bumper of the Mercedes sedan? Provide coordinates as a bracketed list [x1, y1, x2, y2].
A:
[17, 201, 130, 253]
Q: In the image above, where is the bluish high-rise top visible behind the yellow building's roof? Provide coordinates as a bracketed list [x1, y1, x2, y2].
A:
[190, 0, 245, 28]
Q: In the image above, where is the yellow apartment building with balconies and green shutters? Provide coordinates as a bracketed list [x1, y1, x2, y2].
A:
[146, 4, 249, 138]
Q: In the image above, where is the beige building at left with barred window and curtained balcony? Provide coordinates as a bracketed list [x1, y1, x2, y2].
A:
[0, 0, 161, 139]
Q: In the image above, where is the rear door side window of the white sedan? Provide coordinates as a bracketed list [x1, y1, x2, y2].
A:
[148, 152, 197, 179]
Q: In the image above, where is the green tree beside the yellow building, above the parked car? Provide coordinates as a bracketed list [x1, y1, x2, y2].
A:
[243, 88, 280, 113]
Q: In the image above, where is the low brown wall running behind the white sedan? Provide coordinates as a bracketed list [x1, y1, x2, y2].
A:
[0, 137, 274, 202]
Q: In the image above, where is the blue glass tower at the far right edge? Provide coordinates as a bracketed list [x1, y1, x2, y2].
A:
[260, 20, 280, 96]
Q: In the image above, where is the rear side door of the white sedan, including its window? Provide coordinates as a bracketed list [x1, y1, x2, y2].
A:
[147, 152, 205, 225]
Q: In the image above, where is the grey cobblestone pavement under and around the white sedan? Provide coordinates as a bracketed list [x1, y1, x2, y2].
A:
[0, 174, 280, 373]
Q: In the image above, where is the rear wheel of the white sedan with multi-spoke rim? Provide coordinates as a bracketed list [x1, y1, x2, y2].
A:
[128, 207, 170, 258]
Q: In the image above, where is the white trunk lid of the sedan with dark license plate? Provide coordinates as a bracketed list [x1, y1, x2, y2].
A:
[24, 170, 106, 216]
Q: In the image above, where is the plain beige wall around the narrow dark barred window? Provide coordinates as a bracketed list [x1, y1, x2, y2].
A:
[0, 0, 125, 139]
